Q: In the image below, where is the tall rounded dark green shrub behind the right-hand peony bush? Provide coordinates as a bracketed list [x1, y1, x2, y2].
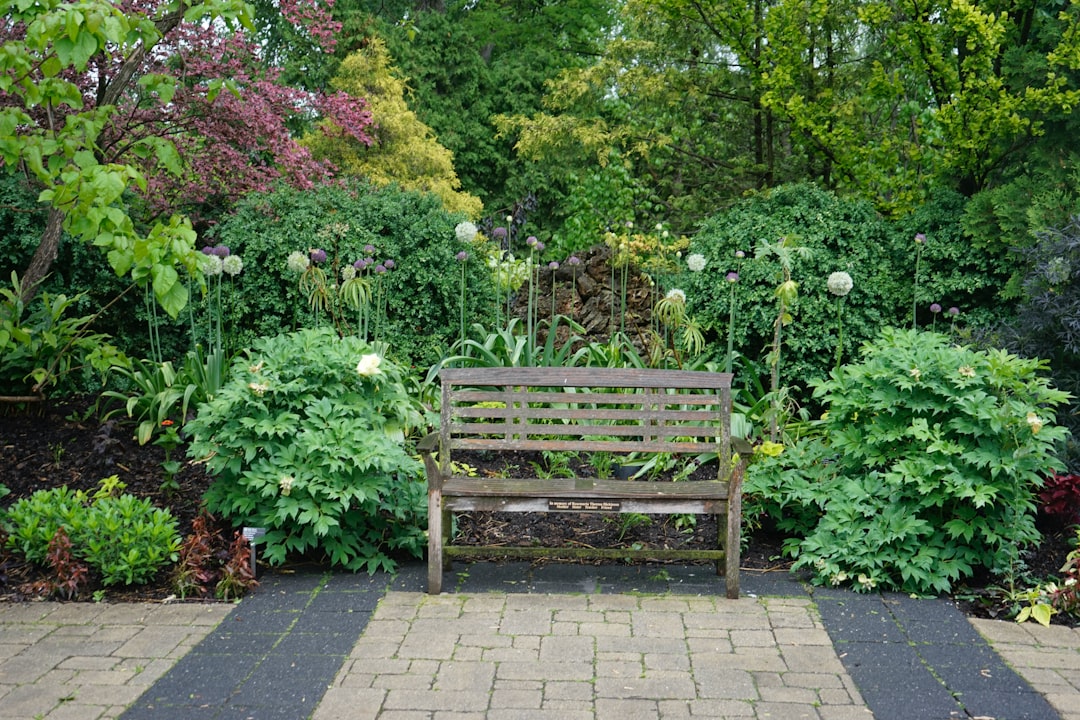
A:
[677, 185, 1009, 396]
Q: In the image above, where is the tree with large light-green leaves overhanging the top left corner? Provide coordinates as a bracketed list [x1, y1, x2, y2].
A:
[0, 0, 247, 315]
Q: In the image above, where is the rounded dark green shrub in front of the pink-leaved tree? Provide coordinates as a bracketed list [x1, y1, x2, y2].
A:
[206, 184, 494, 367]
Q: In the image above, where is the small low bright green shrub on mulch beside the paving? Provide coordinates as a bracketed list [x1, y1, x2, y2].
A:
[5, 479, 180, 586]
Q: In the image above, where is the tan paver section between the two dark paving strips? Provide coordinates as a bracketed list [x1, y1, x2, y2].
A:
[313, 593, 873, 720]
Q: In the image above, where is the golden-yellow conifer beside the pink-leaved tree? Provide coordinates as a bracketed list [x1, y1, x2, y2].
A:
[303, 38, 483, 218]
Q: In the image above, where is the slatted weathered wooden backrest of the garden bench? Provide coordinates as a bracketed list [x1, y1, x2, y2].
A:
[438, 367, 731, 475]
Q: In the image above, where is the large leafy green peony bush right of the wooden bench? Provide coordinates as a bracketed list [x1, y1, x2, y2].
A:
[746, 329, 1067, 593]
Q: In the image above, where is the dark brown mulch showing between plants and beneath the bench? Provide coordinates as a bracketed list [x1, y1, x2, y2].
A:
[0, 397, 1075, 616]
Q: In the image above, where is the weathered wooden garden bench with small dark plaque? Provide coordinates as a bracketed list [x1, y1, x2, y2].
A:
[419, 367, 744, 598]
